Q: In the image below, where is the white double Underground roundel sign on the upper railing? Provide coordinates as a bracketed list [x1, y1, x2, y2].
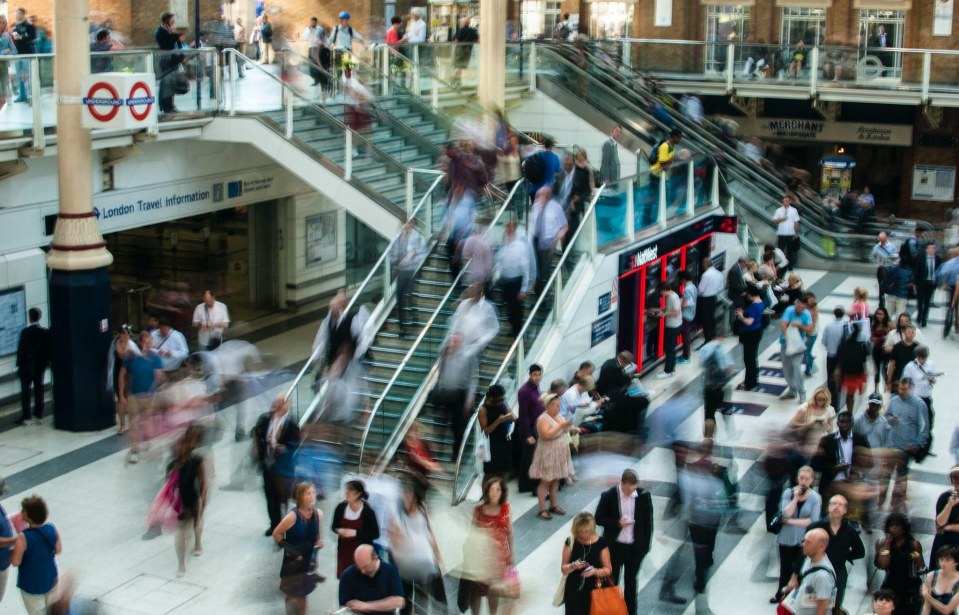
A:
[81, 73, 157, 130]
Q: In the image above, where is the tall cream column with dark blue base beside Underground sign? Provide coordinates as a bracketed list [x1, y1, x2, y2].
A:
[47, 0, 114, 431]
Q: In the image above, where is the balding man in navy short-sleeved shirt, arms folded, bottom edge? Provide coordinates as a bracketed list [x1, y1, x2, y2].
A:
[339, 545, 406, 615]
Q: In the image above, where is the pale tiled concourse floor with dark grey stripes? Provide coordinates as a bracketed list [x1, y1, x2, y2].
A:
[0, 271, 959, 615]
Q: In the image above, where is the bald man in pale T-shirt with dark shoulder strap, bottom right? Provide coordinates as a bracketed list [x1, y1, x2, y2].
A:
[782, 528, 836, 615]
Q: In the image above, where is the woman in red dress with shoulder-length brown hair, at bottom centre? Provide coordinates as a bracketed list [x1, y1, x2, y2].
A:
[466, 476, 519, 615]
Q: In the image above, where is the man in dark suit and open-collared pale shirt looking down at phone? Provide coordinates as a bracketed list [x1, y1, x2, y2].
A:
[596, 470, 653, 615]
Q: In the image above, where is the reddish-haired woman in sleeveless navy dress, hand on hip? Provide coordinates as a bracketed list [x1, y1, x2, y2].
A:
[273, 482, 326, 615]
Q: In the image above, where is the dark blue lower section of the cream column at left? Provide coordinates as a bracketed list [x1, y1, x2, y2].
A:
[50, 267, 116, 431]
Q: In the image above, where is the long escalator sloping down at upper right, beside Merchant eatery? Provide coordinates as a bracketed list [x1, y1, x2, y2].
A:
[536, 45, 928, 265]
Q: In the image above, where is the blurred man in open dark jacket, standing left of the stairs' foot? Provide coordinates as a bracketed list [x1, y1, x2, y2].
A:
[253, 393, 300, 536]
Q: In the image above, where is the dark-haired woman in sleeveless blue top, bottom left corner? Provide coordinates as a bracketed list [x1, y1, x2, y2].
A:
[10, 495, 63, 615]
